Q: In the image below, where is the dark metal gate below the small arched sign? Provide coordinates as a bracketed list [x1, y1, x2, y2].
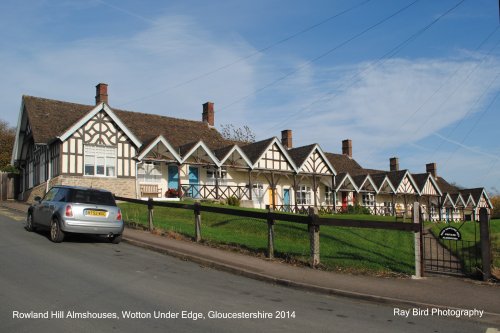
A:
[423, 234, 481, 275]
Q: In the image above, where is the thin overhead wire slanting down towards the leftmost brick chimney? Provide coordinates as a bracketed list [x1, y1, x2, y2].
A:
[115, 0, 372, 107]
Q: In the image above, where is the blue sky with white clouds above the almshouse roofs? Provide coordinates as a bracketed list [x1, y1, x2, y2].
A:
[0, 0, 500, 194]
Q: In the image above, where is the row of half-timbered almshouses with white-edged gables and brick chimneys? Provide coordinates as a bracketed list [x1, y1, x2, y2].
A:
[12, 84, 491, 220]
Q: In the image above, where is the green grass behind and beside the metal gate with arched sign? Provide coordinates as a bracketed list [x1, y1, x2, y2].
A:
[430, 219, 500, 268]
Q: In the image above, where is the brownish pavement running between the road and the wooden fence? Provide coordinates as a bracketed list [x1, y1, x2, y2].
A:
[0, 201, 500, 327]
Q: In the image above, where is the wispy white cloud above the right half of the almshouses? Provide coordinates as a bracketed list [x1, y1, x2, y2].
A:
[256, 56, 500, 152]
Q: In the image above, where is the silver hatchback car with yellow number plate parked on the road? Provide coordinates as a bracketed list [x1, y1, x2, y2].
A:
[26, 186, 123, 244]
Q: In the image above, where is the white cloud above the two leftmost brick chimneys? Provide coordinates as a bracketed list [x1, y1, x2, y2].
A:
[0, 16, 255, 123]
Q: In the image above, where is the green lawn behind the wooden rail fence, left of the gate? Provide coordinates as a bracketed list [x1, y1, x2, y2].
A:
[119, 203, 414, 274]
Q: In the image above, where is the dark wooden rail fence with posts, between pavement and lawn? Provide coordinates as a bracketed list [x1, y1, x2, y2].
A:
[115, 197, 422, 272]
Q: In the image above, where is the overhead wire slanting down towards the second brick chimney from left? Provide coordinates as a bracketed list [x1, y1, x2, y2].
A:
[219, 0, 420, 110]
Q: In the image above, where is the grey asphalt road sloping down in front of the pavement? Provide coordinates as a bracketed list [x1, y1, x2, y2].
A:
[0, 208, 488, 333]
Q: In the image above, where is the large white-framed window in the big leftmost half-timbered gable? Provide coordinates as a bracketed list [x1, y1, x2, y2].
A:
[84, 146, 116, 177]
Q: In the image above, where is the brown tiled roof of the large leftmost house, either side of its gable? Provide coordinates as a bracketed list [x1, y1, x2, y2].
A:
[23, 96, 233, 149]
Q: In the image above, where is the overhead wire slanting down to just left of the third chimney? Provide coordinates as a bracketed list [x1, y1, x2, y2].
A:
[268, 0, 465, 130]
